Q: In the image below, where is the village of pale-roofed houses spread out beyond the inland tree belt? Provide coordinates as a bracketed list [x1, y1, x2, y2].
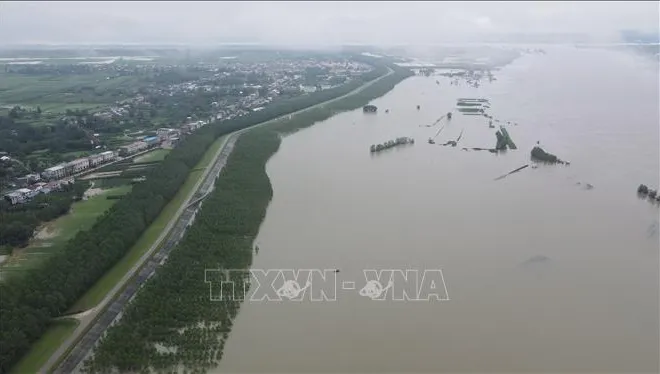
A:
[0, 58, 372, 205]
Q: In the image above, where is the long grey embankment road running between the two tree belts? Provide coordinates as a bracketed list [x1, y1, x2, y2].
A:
[39, 69, 394, 373]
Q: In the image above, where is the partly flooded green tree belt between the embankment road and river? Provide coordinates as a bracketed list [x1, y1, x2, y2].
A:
[86, 65, 410, 373]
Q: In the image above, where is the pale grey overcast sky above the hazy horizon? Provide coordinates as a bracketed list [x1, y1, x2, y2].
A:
[0, 1, 659, 44]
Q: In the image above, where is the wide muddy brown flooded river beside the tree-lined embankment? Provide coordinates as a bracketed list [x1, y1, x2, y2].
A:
[215, 47, 660, 373]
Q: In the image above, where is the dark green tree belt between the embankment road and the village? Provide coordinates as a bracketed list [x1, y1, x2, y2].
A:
[0, 58, 386, 373]
